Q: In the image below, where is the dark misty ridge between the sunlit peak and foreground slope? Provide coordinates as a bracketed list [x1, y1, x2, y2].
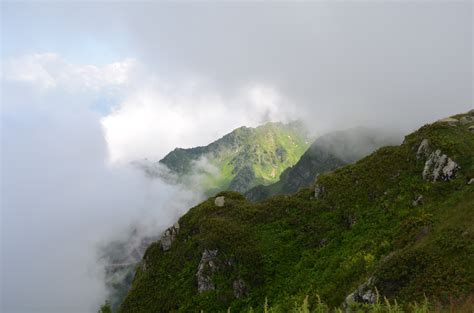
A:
[245, 127, 401, 201]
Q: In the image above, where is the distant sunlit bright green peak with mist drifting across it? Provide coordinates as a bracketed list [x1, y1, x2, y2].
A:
[160, 122, 310, 194]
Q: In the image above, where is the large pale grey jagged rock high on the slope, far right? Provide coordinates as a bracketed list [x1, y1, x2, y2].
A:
[422, 149, 461, 182]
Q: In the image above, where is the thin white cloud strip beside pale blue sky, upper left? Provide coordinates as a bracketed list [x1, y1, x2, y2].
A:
[4, 53, 136, 91]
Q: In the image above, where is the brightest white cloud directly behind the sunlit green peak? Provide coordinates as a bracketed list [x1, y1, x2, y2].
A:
[102, 80, 294, 162]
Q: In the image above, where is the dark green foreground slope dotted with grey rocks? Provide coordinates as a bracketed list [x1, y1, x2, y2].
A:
[121, 110, 474, 313]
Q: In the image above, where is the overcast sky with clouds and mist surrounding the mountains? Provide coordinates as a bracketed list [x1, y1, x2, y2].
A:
[0, 1, 474, 313]
